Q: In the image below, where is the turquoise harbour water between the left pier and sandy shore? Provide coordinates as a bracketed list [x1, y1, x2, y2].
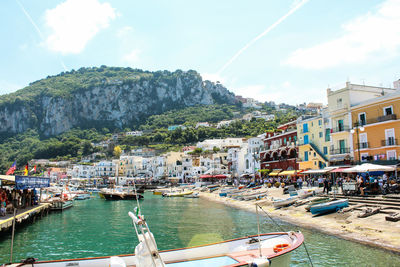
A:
[0, 193, 400, 266]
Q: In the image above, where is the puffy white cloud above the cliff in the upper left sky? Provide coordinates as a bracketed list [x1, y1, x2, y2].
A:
[45, 0, 117, 54]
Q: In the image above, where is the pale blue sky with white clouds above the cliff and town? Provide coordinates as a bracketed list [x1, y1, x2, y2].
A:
[0, 0, 400, 104]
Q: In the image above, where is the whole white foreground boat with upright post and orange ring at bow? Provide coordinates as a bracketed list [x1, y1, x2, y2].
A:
[7, 211, 304, 267]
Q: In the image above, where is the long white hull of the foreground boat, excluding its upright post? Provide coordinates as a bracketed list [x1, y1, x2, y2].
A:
[6, 232, 304, 267]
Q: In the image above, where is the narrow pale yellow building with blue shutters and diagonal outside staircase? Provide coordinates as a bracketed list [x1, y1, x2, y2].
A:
[297, 115, 330, 170]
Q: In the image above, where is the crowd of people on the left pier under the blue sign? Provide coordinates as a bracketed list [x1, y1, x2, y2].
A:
[0, 188, 38, 216]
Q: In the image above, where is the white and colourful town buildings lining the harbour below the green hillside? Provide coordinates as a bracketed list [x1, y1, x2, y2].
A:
[30, 81, 400, 183]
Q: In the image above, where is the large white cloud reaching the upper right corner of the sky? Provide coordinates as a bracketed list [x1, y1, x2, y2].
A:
[284, 0, 400, 69]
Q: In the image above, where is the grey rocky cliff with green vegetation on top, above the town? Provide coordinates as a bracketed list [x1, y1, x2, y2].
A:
[0, 66, 235, 136]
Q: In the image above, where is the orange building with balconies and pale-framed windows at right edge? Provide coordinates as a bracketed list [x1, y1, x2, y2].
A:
[351, 90, 400, 164]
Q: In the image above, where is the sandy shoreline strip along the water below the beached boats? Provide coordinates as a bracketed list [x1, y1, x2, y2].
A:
[199, 188, 400, 254]
